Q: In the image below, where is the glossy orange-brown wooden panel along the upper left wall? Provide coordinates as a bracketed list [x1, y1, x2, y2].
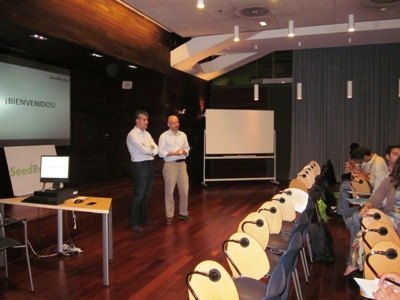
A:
[0, 0, 171, 72]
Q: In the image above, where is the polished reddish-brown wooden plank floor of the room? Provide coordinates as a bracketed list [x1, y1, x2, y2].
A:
[0, 178, 361, 300]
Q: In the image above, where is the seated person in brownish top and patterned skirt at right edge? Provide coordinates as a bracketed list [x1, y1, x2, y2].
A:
[343, 157, 400, 278]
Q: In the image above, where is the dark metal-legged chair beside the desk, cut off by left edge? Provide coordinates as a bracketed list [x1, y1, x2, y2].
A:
[0, 213, 34, 292]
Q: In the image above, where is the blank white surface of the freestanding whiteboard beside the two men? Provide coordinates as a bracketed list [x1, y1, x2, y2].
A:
[205, 109, 274, 155]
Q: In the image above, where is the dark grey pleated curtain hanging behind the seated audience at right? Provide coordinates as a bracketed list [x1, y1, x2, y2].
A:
[290, 43, 400, 178]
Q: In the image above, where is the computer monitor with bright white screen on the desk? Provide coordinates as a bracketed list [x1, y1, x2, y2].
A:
[40, 155, 69, 189]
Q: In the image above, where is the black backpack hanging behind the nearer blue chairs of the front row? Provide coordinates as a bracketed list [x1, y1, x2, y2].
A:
[308, 222, 335, 263]
